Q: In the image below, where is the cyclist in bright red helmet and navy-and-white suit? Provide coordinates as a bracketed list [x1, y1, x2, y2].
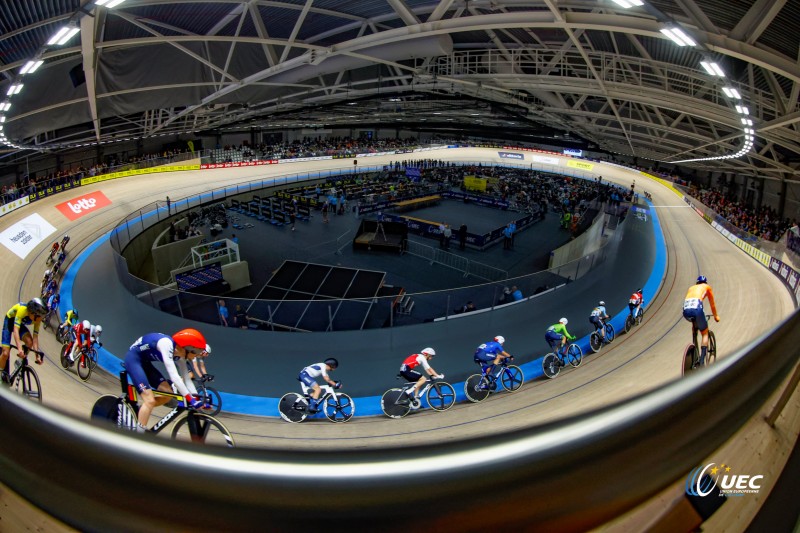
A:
[125, 328, 206, 433]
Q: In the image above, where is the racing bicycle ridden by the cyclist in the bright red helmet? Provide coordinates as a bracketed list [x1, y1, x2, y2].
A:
[91, 370, 235, 448]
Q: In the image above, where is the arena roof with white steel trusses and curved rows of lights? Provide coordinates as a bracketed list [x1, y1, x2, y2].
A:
[0, 0, 800, 179]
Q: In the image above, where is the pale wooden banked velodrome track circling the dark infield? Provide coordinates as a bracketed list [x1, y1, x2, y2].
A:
[0, 145, 794, 528]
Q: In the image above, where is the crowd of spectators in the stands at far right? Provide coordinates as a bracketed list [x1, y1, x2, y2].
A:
[690, 190, 796, 241]
